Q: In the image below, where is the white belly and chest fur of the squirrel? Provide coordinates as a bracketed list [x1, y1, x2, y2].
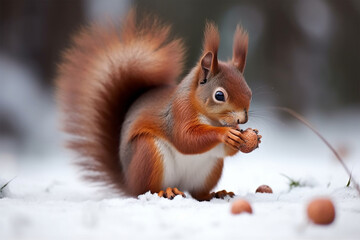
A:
[156, 139, 225, 191]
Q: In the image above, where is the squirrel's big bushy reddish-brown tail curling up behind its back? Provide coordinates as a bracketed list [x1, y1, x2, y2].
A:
[56, 12, 184, 193]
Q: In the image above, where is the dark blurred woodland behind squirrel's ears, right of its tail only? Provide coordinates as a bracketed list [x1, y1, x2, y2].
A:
[135, 0, 360, 111]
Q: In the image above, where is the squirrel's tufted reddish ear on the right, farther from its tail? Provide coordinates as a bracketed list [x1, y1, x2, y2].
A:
[232, 25, 249, 73]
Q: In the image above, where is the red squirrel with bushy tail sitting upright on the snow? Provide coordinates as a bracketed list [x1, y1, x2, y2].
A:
[56, 12, 261, 200]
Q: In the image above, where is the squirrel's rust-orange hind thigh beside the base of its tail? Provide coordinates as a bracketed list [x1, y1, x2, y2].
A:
[126, 136, 163, 196]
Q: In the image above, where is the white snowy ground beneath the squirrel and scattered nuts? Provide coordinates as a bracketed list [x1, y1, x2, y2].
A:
[0, 111, 360, 240]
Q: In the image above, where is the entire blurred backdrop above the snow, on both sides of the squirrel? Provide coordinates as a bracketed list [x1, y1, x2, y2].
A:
[0, 0, 360, 164]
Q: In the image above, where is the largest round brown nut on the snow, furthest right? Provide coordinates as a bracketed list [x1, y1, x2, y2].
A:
[307, 198, 335, 225]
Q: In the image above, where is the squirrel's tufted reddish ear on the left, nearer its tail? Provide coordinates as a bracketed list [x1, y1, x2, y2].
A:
[201, 22, 220, 74]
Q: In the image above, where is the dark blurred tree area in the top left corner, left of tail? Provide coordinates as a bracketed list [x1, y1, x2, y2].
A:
[0, 0, 84, 85]
